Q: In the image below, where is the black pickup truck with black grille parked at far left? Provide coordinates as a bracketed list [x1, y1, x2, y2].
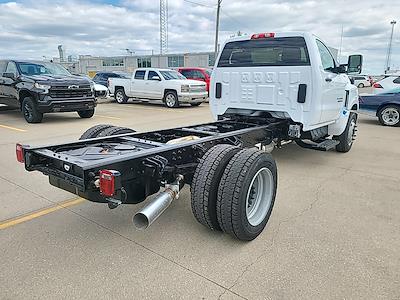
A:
[0, 60, 96, 123]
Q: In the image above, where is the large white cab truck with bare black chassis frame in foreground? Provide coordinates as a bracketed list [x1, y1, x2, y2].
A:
[16, 33, 362, 241]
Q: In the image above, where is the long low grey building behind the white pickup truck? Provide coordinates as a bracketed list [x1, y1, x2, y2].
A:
[63, 52, 215, 76]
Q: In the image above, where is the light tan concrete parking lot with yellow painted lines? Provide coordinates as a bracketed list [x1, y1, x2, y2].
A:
[0, 103, 400, 299]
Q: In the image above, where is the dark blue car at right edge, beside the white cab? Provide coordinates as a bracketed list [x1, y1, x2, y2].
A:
[360, 88, 400, 126]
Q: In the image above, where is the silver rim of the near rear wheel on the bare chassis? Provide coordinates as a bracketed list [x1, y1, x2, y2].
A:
[246, 168, 274, 226]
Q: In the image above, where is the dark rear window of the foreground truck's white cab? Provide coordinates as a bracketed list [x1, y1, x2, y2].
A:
[218, 37, 310, 67]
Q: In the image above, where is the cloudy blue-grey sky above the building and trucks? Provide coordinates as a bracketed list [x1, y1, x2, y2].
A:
[0, 0, 400, 74]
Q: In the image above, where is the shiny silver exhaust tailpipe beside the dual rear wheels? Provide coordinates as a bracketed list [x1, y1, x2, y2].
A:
[132, 175, 183, 230]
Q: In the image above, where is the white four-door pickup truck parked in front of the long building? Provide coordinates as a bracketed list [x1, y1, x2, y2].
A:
[108, 68, 208, 108]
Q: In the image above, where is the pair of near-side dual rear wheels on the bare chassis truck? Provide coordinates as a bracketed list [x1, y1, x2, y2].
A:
[191, 145, 277, 241]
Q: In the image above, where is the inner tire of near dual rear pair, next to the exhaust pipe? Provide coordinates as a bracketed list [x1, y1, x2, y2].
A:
[190, 144, 240, 230]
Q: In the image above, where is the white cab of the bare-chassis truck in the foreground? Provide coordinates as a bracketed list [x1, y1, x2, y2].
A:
[210, 32, 362, 136]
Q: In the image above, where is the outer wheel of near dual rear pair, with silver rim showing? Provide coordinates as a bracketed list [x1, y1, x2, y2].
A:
[217, 148, 277, 241]
